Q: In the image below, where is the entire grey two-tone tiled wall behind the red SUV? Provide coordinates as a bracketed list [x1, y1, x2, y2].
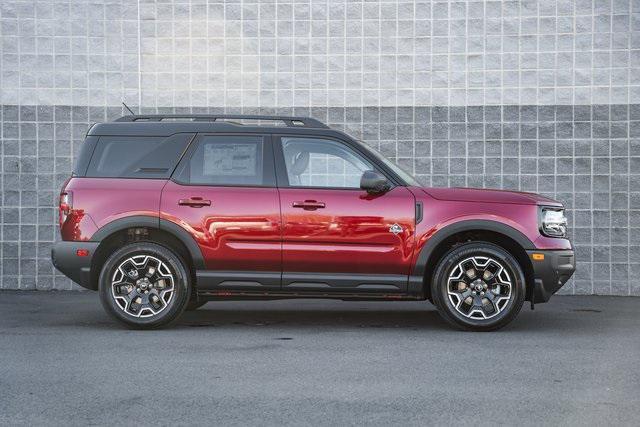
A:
[0, 0, 640, 295]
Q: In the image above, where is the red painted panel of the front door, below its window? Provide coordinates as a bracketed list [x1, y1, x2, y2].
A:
[279, 187, 415, 275]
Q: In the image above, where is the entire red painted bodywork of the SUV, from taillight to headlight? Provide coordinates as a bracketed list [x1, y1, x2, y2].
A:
[61, 178, 571, 276]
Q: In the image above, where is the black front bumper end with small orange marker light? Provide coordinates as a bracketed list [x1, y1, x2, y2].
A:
[527, 250, 576, 303]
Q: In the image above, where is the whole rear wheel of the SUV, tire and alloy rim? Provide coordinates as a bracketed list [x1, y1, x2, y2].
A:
[99, 242, 191, 329]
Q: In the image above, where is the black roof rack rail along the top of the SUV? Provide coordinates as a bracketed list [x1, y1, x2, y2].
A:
[114, 114, 328, 128]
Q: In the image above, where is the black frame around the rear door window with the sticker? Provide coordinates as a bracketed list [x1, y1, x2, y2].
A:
[169, 132, 276, 188]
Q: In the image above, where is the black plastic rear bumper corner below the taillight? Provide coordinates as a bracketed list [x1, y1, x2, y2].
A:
[51, 242, 100, 290]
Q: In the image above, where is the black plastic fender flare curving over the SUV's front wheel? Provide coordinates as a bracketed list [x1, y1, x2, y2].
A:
[413, 219, 535, 277]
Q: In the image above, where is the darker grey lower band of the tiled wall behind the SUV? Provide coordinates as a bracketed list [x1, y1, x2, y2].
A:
[1, 105, 640, 295]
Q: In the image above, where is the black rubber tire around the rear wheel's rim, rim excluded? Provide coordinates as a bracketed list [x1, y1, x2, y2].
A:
[99, 242, 191, 329]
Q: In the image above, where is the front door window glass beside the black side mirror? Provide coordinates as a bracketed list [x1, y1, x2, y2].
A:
[281, 137, 374, 188]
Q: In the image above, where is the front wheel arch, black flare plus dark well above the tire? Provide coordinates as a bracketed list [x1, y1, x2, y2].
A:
[413, 220, 535, 300]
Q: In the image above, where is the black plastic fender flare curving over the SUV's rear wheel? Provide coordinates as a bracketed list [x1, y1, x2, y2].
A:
[91, 215, 205, 270]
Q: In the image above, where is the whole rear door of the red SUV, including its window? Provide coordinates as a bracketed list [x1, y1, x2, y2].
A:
[160, 134, 281, 291]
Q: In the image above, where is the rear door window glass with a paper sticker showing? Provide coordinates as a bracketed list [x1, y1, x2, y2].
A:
[176, 135, 273, 186]
